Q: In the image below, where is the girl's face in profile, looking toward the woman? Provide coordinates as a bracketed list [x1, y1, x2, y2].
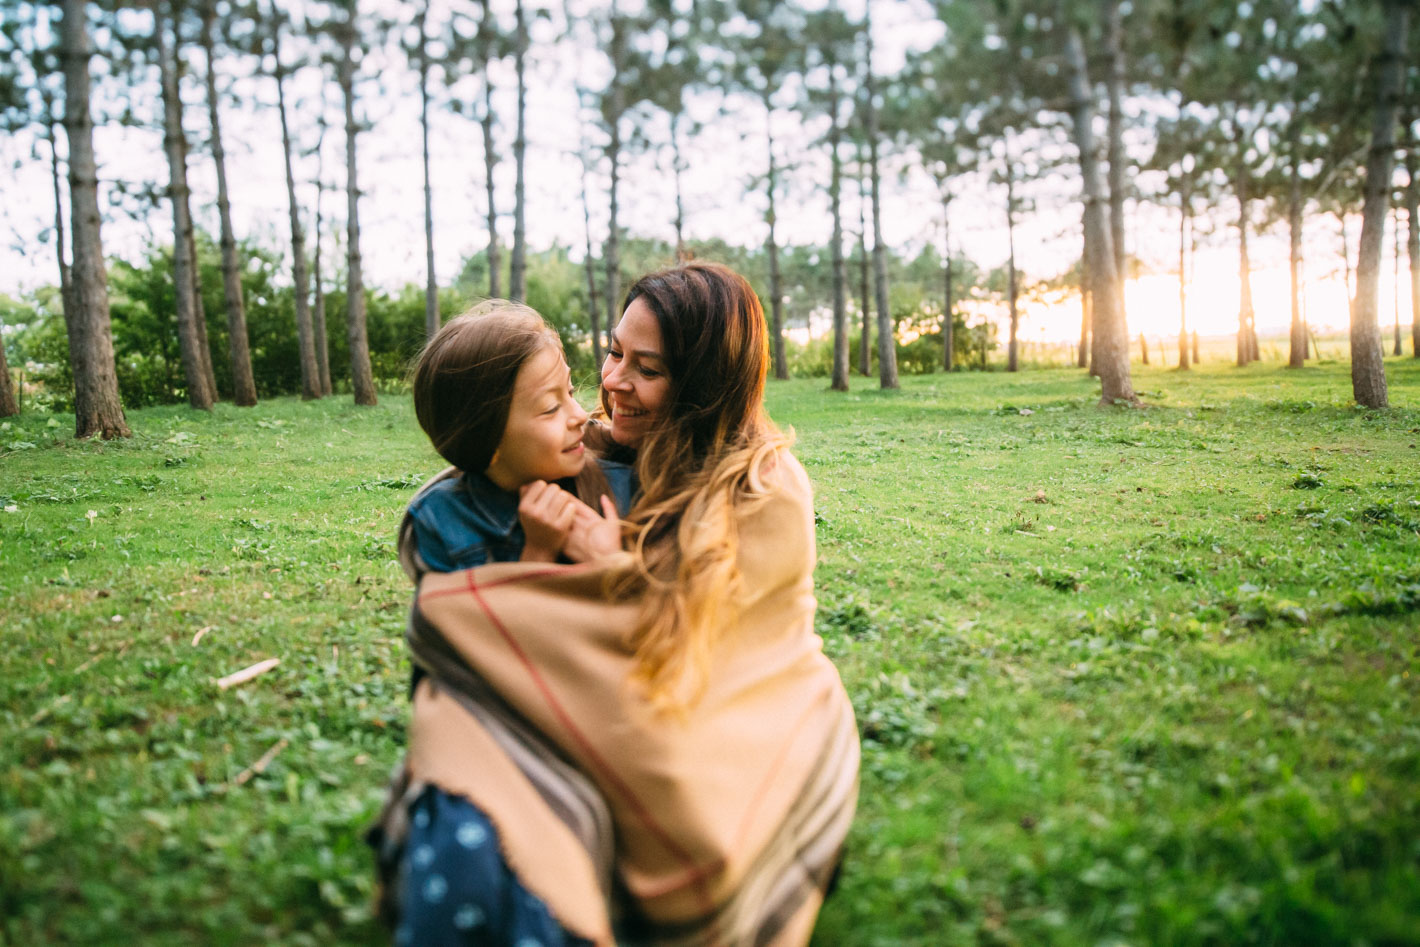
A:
[486, 346, 586, 491]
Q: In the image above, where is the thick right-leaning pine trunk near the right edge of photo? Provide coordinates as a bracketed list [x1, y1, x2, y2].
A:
[1350, 0, 1410, 407]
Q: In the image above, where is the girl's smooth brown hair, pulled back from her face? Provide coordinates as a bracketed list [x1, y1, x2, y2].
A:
[412, 300, 561, 473]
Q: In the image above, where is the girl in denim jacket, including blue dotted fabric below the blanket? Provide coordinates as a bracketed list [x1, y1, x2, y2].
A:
[383, 300, 635, 947]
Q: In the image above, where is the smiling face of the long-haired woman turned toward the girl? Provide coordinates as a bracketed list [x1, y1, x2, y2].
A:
[602, 297, 670, 447]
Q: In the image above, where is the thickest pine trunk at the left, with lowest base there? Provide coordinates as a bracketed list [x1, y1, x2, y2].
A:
[60, 0, 129, 440]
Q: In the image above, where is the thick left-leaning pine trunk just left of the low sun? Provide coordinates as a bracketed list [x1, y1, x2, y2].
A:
[1062, 17, 1137, 406]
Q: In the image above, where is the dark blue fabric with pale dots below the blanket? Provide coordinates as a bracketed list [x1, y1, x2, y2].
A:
[395, 787, 592, 947]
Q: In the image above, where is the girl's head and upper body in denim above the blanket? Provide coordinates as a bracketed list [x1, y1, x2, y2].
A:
[403, 300, 633, 578]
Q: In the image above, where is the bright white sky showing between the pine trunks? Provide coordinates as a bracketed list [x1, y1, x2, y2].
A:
[0, 0, 1410, 341]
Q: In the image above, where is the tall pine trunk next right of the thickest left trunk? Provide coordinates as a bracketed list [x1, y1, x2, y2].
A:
[153, 3, 213, 410]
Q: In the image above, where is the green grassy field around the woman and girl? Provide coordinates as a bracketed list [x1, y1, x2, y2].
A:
[0, 359, 1420, 947]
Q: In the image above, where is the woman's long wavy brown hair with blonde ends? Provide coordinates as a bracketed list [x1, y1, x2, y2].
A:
[602, 261, 790, 708]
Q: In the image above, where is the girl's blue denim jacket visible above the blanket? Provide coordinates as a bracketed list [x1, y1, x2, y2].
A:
[409, 460, 636, 572]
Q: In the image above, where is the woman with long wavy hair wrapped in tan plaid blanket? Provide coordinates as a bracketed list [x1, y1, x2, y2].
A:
[383, 264, 858, 944]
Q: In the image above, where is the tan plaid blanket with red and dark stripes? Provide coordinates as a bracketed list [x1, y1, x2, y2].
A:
[381, 451, 858, 947]
